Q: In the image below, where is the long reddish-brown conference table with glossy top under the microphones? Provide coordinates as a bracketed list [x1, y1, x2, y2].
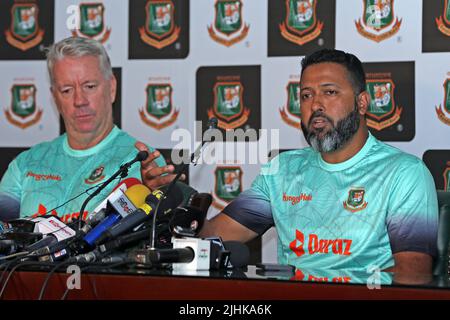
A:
[1, 265, 450, 301]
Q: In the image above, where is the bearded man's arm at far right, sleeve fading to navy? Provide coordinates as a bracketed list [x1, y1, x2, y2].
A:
[386, 161, 438, 275]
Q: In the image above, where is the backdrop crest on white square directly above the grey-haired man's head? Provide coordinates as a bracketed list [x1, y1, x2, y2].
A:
[72, 3, 111, 43]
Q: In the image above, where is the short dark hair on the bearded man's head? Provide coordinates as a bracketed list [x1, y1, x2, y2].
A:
[301, 49, 366, 95]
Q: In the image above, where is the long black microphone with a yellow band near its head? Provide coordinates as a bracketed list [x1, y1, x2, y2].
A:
[95, 185, 183, 245]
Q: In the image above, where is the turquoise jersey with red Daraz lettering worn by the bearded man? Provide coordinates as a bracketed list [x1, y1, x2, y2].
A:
[224, 134, 438, 270]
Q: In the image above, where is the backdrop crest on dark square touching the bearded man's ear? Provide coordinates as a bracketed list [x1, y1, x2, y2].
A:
[366, 74, 403, 131]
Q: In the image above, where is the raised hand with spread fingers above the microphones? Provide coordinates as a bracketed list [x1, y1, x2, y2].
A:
[134, 142, 185, 190]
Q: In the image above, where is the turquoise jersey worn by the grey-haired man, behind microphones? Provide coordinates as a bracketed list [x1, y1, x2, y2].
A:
[0, 127, 165, 221]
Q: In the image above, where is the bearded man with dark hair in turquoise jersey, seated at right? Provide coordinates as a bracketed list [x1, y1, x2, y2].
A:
[201, 49, 438, 274]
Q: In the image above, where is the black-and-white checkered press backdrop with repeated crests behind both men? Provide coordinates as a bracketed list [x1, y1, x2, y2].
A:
[0, 0, 450, 262]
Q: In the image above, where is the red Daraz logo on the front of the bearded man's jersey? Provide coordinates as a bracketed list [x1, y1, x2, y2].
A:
[289, 230, 352, 257]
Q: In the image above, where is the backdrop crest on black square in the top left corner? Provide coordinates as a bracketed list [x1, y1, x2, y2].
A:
[5, 3, 44, 51]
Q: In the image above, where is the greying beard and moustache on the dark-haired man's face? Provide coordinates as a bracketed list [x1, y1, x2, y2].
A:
[301, 107, 360, 153]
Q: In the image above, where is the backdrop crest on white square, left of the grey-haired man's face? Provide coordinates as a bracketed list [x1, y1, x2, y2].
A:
[5, 84, 42, 129]
